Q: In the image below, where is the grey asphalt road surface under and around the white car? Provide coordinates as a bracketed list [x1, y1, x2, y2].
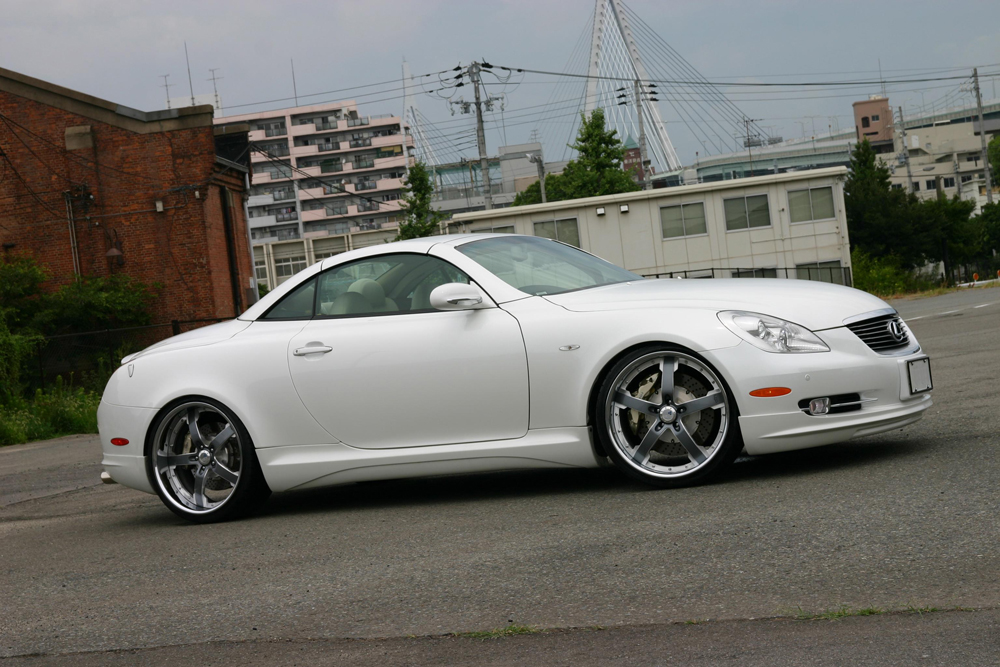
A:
[0, 289, 1000, 665]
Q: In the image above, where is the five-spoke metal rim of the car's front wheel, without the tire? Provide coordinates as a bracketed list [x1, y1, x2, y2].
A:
[604, 350, 731, 480]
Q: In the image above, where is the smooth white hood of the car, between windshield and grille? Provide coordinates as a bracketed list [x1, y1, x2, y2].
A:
[545, 278, 889, 331]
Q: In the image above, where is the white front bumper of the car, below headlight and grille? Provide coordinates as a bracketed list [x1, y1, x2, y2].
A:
[705, 328, 932, 454]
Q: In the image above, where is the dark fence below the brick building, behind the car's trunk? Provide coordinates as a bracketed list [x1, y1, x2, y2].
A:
[27, 318, 230, 389]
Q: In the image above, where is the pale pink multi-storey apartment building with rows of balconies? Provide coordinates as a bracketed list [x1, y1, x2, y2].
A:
[215, 100, 413, 289]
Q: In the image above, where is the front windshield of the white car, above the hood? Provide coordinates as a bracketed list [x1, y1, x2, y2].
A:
[458, 236, 643, 296]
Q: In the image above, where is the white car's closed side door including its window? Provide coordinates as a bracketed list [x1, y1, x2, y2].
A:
[288, 253, 528, 448]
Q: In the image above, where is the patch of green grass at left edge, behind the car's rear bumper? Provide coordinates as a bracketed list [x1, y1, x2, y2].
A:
[0, 377, 101, 446]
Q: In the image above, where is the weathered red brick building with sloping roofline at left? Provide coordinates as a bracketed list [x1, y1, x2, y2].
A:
[0, 69, 257, 322]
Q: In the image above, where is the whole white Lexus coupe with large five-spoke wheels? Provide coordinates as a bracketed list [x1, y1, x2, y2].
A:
[98, 234, 931, 521]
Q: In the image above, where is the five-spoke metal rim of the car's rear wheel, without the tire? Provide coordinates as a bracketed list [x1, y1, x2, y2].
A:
[152, 402, 246, 513]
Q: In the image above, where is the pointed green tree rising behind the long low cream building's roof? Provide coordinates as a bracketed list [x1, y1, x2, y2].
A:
[513, 109, 640, 206]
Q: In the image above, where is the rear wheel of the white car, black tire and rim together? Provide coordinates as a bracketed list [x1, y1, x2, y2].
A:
[146, 397, 271, 523]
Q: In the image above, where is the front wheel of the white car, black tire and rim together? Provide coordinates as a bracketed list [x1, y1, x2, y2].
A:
[593, 344, 743, 488]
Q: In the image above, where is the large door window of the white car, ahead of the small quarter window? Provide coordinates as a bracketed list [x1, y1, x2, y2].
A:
[316, 254, 469, 318]
